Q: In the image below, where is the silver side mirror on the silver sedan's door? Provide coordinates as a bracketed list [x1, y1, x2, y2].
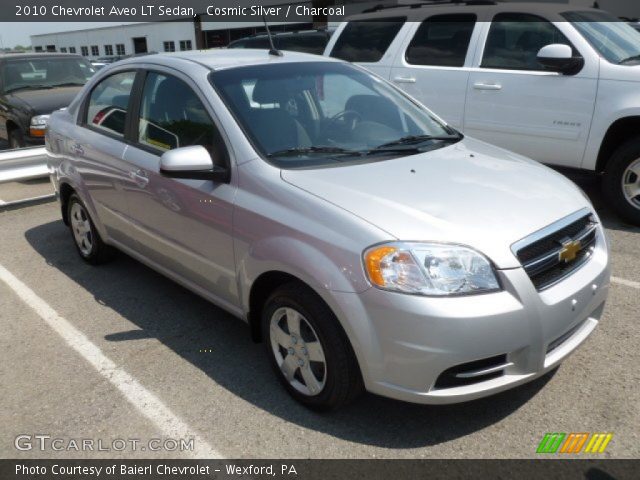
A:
[160, 145, 230, 183]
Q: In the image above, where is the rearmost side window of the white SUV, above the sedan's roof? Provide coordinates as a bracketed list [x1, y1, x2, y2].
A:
[331, 17, 406, 62]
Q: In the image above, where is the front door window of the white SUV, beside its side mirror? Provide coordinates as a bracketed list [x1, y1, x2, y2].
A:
[481, 13, 573, 71]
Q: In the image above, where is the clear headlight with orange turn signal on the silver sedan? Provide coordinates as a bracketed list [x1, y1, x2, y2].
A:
[364, 242, 501, 296]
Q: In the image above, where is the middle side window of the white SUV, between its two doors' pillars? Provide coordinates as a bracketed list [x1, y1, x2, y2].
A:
[405, 14, 478, 67]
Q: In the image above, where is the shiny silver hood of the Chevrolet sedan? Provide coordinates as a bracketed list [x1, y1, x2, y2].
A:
[281, 138, 591, 268]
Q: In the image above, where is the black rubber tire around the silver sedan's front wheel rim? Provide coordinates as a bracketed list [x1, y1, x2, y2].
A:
[262, 282, 364, 411]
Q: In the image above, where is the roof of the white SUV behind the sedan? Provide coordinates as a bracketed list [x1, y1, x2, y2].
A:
[346, 1, 602, 22]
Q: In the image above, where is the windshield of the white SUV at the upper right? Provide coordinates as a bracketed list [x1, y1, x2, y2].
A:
[563, 11, 640, 65]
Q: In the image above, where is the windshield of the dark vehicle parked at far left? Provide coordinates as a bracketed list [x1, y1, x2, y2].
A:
[0, 56, 95, 93]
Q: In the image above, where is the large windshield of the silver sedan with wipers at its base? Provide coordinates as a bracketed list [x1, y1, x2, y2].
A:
[211, 62, 461, 168]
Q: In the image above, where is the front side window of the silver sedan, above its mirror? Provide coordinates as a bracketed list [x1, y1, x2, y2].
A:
[138, 72, 226, 159]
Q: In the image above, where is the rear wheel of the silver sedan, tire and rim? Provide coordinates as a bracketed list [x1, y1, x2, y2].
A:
[67, 193, 113, 265]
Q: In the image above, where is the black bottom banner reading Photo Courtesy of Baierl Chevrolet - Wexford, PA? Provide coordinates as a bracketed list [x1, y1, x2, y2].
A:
[0, 460, 640, 480]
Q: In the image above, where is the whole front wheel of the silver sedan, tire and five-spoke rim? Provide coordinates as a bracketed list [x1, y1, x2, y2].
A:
[262, 283, 363, 411]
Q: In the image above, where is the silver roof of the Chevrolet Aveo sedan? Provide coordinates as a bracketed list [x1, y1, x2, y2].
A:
[113, 48, 342, 70]
